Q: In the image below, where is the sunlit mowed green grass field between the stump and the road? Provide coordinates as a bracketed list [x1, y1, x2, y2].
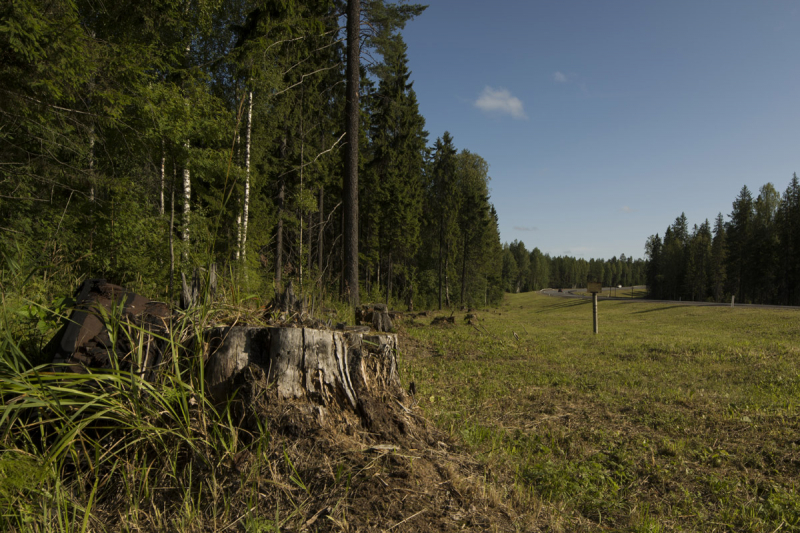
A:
[401, 293, 800, 533]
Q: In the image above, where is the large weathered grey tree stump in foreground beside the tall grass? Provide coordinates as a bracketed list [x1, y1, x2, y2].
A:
[205, 326, 399, 410]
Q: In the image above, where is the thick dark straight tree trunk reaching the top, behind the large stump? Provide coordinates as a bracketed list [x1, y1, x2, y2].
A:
[342, 0, 361, 306]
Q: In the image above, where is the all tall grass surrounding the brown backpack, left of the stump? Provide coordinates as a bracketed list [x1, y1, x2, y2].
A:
[0, 246, 318, 532]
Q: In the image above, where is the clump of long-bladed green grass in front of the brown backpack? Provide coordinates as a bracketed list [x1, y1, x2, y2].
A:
[0, 298, 233, 531]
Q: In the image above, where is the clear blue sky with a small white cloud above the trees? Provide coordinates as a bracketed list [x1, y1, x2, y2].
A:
[403, 0, 800, 259]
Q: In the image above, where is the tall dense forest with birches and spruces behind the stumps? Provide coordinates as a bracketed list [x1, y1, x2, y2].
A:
[0, 0, 505, 307]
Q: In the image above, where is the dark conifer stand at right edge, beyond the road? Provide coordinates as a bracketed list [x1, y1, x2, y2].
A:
[646, 174, 800, 305]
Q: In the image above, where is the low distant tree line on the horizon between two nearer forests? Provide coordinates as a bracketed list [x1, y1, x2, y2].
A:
[502, 240, 647, 292]
